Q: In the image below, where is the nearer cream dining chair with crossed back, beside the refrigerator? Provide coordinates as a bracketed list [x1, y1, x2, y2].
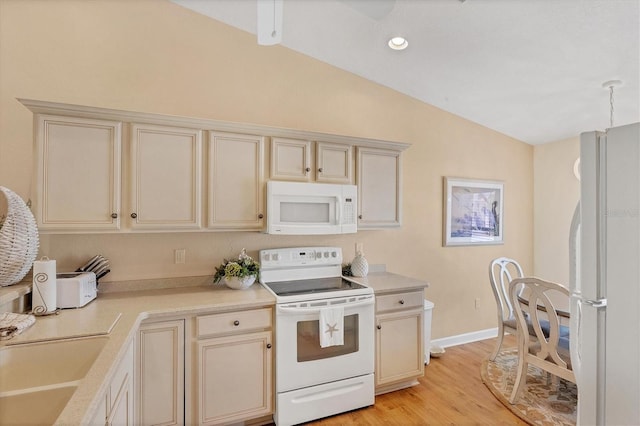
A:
[509, 277, 576, 404]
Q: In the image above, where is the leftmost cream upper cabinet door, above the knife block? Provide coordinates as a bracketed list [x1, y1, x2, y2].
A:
[33, 115, 121, 232]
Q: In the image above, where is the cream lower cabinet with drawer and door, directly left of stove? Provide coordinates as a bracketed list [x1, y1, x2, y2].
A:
[193, 308, 274, 425]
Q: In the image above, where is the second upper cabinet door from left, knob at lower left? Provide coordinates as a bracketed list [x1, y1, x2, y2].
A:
[129, 124, 202, 230]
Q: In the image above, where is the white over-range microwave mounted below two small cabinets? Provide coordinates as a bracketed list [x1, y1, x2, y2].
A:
[267, 181, 358, 235]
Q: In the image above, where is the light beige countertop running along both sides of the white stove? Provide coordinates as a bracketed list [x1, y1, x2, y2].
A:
[0, 272, 429, 424]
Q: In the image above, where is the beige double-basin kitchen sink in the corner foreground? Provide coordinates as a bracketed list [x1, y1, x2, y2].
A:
[0, 336, 109, 424]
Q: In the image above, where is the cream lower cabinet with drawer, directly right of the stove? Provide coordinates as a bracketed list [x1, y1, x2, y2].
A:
[375, 290, 424, 394]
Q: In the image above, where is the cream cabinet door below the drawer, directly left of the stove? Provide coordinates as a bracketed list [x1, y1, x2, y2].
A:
[197, 331, 273, 424]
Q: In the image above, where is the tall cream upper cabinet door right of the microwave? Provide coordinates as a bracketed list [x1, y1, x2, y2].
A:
[356, 148, 402, 229]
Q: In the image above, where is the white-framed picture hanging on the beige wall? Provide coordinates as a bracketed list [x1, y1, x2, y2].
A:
[443, 177, 504, 246]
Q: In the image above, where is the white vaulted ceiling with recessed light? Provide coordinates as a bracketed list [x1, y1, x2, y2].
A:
[173, 0, 640, 144]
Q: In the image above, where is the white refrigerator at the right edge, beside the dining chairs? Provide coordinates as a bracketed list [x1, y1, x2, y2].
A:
[569, 123, 640, 425]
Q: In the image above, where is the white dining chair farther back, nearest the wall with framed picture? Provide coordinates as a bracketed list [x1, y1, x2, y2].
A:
[489, 257, 524, 361]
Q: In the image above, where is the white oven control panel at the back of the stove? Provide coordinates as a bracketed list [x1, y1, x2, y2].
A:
[260, 247, 342, 269]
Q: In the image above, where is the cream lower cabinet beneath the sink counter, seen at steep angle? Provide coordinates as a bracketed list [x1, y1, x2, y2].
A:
[89, 342, 134, 426]
